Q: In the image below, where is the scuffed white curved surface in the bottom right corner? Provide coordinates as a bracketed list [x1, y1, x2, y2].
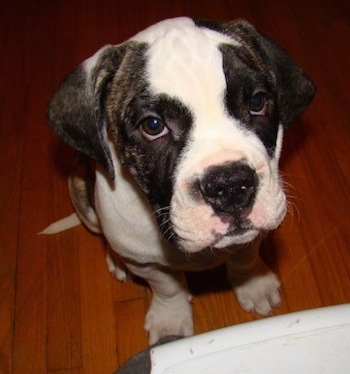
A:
[151, 304, 350, 374]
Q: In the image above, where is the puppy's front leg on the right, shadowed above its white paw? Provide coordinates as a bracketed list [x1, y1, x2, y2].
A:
[226, 238, 281, 316]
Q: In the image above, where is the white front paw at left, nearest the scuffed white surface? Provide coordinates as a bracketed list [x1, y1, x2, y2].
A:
[144, 295, 193, 344]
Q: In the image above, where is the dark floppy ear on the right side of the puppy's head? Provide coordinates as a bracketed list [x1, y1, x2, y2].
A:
[225, 20, 316, 128]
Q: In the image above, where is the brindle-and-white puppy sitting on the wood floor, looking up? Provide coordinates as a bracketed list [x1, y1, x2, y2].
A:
[46, 18, 315, 343]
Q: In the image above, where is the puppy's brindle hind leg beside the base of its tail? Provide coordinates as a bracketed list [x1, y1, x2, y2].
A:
[68, 155, 101, 234]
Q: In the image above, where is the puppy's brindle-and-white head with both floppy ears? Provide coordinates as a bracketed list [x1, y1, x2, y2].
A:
[48, 18, 315, 252]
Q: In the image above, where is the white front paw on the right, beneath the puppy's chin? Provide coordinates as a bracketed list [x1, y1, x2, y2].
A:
[234, 271, 281, 316]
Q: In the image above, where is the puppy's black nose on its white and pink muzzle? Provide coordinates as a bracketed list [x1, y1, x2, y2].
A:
[199, 162, 258, 216]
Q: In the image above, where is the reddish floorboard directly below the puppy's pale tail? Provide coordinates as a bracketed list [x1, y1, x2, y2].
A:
[47, 230, 82, 371]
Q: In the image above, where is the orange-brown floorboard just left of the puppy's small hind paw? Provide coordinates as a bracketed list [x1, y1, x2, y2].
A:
[79, 231, 117, 374]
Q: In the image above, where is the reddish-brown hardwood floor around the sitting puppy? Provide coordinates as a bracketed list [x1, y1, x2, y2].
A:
[0, 0, 350, 374]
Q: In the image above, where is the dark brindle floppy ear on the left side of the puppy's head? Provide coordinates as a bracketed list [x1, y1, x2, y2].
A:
[47, 45, 126, 180]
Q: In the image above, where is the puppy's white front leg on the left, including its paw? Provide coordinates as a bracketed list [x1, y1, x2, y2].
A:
[126, 263, 193, 344]
